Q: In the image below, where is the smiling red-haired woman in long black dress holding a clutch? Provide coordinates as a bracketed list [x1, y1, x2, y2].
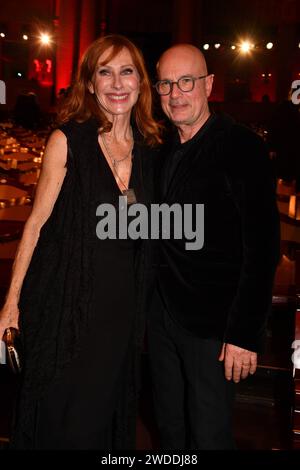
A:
[0, 35, 160, 449]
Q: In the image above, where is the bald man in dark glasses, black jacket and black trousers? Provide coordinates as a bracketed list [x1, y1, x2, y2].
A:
[148, 44, 279, 449]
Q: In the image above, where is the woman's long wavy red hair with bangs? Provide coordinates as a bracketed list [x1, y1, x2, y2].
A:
[58, 34, 161, 145]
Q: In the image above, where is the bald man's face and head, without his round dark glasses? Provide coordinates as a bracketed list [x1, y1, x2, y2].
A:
[158, 46, 213, 127]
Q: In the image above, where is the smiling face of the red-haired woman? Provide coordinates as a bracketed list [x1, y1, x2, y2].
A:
[89, 48, 140, 117]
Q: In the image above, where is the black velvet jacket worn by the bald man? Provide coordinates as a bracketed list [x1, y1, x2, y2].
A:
[153, 115, 280, 351]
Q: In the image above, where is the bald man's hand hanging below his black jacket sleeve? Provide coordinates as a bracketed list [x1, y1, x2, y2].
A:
[219, 343, 257, 383]
